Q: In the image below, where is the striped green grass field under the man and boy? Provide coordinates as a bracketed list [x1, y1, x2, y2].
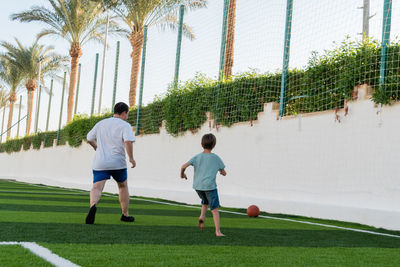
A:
[0, 180, 400, 266]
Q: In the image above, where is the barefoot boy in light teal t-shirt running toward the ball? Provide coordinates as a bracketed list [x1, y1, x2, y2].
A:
[181, 134, 226, 236]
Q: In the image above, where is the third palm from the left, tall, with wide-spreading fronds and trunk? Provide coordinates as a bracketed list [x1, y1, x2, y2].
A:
[11, 0, 121, 122]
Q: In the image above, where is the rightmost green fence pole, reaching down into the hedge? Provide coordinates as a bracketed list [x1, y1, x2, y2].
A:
[379, 0, 392, 90]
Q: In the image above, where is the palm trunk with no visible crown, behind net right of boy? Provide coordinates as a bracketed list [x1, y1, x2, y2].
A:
[224, 0, 236, 79]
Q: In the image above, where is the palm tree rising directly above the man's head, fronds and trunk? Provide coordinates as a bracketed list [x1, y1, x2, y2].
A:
[111, 0, 207, 106]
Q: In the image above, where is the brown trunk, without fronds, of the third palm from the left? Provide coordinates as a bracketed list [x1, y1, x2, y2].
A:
[67, 42, 82, 122]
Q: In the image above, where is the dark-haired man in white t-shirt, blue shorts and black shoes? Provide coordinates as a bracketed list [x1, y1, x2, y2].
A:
[86, 102, 136, 224]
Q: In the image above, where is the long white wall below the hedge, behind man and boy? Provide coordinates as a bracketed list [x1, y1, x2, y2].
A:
[0, 93, 400, 230]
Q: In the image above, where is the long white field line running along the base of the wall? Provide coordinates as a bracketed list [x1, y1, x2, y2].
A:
[4, 181, 400, 241]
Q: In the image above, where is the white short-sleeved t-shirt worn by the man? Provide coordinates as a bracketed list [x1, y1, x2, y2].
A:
[86, 117, 135, 171]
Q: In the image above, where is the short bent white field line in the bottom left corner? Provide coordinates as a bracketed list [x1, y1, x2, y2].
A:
[0, 242, 79, 267]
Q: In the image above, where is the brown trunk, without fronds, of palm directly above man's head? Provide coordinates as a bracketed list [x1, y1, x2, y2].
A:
[129, 29, 143, 107]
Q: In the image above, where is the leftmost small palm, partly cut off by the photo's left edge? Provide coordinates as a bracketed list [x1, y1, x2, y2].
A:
[0, 60, 23, 138]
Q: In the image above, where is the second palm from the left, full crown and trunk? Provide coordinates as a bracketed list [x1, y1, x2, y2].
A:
[0, 39, 66, 134]
